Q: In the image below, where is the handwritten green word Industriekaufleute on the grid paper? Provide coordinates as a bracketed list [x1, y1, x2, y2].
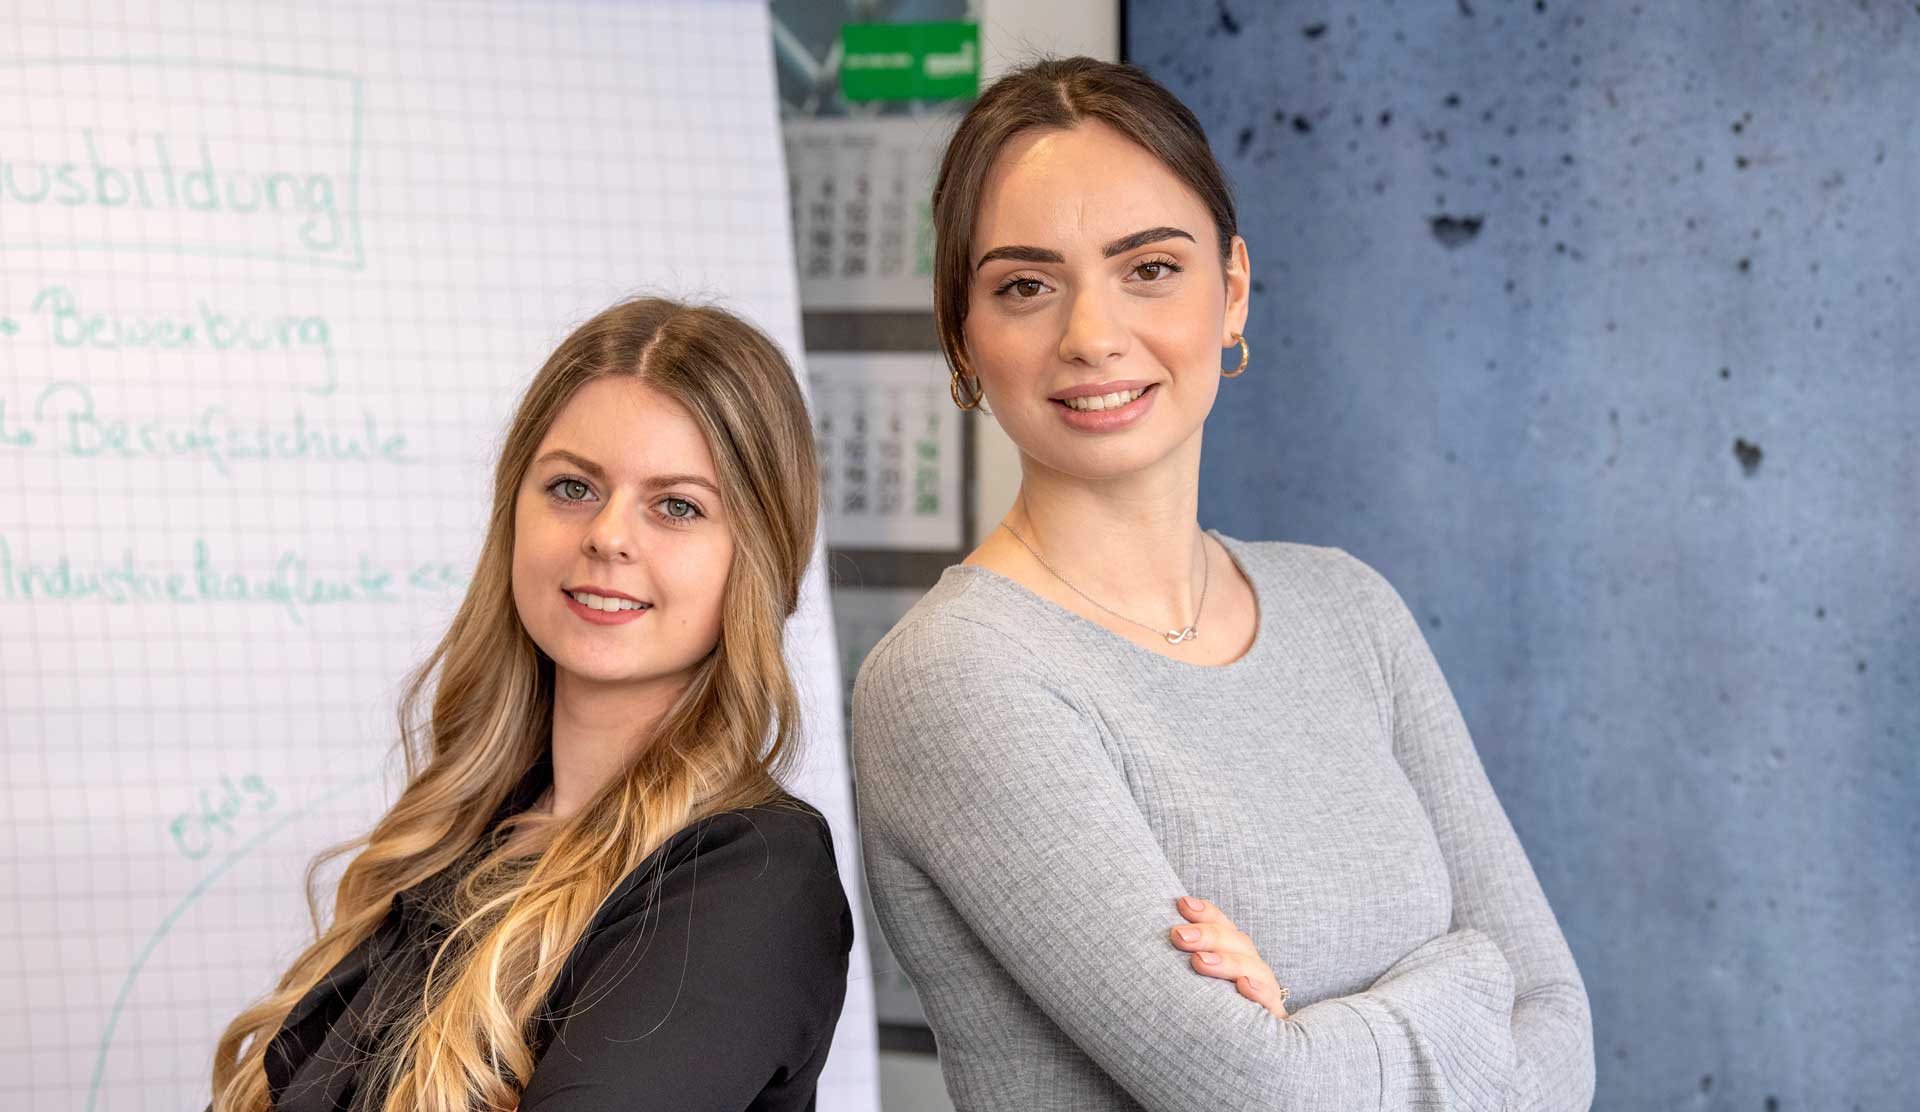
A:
[0, 536, 468, 626]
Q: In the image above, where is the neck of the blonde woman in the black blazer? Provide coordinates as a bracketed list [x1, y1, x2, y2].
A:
[553, 668, 685, 818]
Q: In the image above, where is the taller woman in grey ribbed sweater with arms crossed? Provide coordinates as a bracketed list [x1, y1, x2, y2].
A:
[852, 58, 1594, 1112]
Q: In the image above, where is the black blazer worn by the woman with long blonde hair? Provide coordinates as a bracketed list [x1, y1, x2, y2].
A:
[249, 761, 852, 1112]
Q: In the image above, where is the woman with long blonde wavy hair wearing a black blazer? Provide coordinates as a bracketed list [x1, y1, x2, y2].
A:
[211, 300, 852, 1112]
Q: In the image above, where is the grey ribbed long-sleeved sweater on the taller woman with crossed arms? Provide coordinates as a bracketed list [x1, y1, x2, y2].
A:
[852, 532, 1594, 1112]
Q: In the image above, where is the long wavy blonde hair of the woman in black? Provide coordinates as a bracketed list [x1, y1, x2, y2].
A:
[213, 298, 820, 1112]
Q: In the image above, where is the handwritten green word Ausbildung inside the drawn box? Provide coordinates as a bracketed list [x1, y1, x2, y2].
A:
[0, 129, 346, 252]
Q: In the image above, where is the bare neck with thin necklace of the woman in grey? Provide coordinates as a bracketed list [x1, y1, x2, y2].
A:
[1006, 432, 1206, 628]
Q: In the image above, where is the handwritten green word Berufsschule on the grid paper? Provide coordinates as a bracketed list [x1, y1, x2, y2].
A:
[0, 382, 419, 474]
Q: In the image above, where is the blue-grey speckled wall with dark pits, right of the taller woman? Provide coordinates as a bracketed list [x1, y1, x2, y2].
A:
[1127, 0, 1920, 1112]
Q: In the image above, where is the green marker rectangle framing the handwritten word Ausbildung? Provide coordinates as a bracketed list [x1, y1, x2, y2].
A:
[0, 58, 367, 271]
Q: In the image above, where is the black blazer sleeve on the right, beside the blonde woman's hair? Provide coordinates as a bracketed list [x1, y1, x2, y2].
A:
[520, 807, 852, 1112]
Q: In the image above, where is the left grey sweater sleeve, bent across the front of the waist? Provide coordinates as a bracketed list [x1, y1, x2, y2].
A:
[854, 618, 1513, 1112]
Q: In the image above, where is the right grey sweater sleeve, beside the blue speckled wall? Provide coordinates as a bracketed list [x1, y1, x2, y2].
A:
[1354, 559, 1594, 1110]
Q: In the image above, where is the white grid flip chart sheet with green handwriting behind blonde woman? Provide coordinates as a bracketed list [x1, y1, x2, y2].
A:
[0, 0, 877, 1112]
